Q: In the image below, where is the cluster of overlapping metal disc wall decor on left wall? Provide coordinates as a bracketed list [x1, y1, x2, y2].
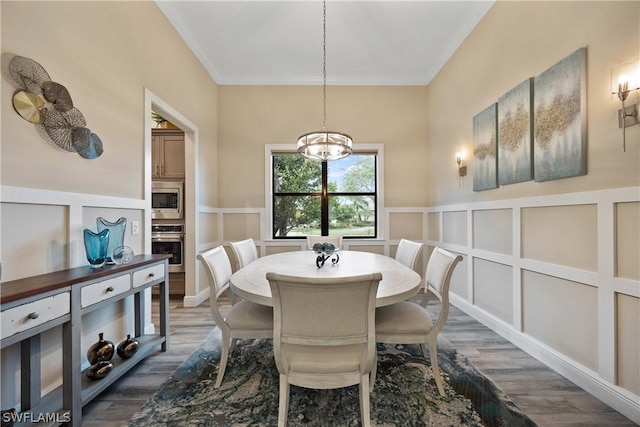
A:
[8, 55, 104, 159]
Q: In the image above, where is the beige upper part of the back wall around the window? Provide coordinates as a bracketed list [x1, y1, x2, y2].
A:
[218, 84, 427, 207]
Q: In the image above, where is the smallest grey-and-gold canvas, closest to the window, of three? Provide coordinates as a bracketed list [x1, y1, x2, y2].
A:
[473, 103, 498, 191]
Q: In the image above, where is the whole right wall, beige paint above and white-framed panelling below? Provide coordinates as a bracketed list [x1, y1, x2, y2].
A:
[424, 1, 640, 422]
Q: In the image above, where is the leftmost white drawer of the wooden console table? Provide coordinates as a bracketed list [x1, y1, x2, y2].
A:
[0, 292, 71, 339]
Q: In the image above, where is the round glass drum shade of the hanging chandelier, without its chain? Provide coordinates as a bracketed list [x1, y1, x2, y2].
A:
[298, 130, 353, 162]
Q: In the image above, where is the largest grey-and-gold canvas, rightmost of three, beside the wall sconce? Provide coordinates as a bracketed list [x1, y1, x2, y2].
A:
[533, 48, 587, 181]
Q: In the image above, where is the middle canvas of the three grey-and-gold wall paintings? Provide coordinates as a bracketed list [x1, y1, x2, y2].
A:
[498, 79, 533, 185]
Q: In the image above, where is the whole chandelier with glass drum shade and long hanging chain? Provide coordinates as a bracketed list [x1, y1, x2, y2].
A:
[298, 0, 353, 161]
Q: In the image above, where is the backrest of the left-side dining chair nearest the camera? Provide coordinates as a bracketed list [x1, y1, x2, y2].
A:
[198, 246, 232, 329]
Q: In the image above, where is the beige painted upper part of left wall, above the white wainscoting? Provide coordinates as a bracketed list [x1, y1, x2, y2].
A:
[1, 1, 216, 198]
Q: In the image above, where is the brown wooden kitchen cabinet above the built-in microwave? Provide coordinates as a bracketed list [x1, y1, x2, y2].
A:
[151, 129, 184, 179]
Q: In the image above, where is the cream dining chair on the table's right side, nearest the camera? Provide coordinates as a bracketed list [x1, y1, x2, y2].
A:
[371, 247, 462, 397]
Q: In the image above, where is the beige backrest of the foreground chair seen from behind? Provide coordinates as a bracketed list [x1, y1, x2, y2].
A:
[267, 273, 382, 374]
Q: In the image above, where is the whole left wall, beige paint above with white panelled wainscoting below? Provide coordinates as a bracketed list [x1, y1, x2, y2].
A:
[0, 1, 217, 408]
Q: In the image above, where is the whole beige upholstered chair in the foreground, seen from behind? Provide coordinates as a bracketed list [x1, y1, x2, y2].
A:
[267, 273, 382, 426]
